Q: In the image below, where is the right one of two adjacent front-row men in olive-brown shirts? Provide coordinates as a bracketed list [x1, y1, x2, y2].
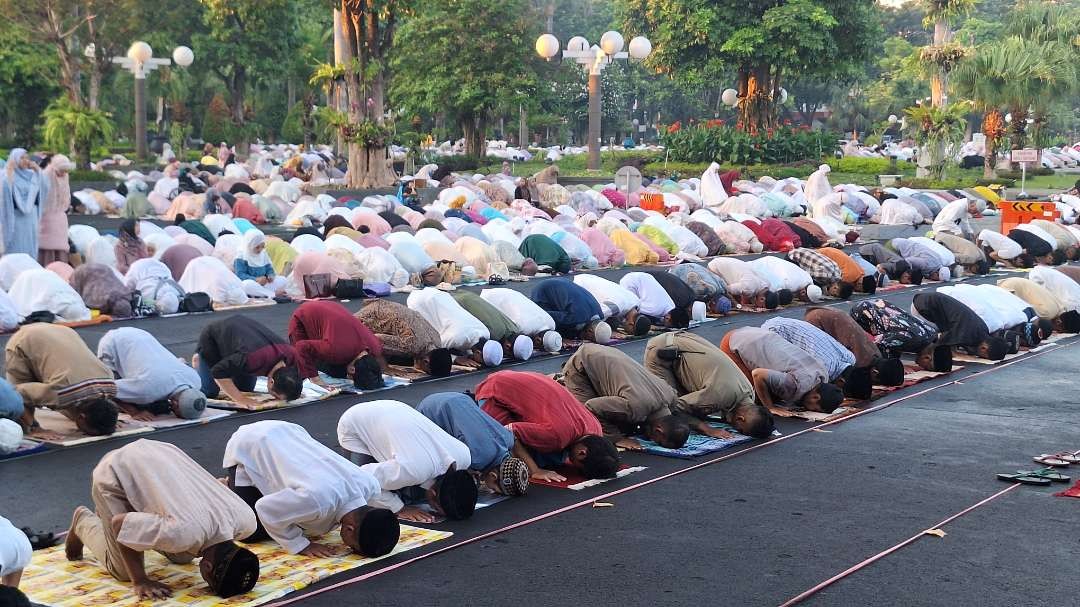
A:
[645, 332, 773, 439]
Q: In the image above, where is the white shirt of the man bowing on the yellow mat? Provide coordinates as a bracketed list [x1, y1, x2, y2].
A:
[222, 420, 381, 554]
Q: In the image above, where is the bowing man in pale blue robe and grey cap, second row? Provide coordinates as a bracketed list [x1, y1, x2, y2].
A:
[97, 327, 206, 420]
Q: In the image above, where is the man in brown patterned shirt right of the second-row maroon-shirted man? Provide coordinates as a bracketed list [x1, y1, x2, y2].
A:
[355, 299, 453, 377]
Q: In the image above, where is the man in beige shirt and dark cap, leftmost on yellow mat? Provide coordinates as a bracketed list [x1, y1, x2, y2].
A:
[64, 440, 259, 601]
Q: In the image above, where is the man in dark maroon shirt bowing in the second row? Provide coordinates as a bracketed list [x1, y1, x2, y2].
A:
[288, 300, 386, 390]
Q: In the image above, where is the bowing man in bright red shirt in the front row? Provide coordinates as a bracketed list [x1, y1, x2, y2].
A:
[476, 370, 619, 482]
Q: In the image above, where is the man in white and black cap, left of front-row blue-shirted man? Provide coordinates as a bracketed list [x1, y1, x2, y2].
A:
[337, 401, 476, 523]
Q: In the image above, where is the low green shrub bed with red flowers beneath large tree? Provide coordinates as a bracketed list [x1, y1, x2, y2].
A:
[660, 124, 837, 165]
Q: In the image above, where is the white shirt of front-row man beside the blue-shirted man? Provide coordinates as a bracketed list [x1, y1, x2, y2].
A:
[338, 401, 472, 512]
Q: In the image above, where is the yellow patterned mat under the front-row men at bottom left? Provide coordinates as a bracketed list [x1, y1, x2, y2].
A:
[19, 525, 454, 607]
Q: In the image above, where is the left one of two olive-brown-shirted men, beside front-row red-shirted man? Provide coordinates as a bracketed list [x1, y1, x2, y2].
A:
[563, 343, 690, 450]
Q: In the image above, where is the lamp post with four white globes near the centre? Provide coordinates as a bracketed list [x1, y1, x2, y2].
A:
[536, 31, 652, 171]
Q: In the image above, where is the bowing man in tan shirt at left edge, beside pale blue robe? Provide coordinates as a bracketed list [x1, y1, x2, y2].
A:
[4, 323, 119, 436]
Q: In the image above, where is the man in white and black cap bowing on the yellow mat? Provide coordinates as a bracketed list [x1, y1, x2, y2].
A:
[222, 419, 400, 558]
